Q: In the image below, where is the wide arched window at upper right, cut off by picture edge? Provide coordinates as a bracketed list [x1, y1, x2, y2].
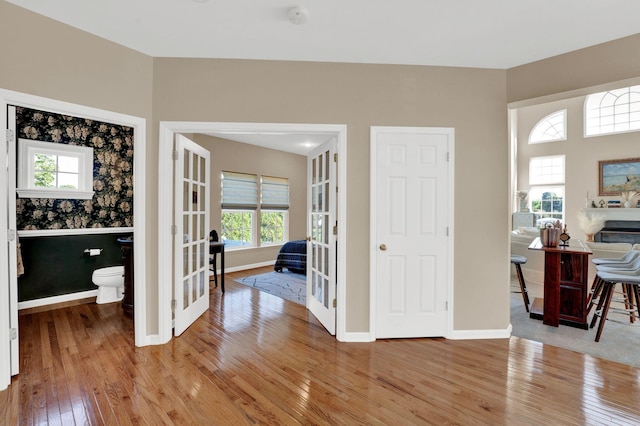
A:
[584, 86, 640, 136]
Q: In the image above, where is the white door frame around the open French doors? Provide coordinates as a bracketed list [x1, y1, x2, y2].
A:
[158, 121, 347, 342]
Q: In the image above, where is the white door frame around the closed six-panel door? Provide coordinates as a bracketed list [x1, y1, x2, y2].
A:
[369, 126, 455, 340]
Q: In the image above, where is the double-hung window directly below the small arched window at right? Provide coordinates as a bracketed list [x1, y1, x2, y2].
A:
[529, 155, 565, 224]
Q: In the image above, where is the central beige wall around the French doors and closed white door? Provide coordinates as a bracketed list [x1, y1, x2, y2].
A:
[148, 58, 509, 332]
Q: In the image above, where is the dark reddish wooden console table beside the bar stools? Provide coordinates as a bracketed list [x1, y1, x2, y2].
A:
[529, 238, 592, 330]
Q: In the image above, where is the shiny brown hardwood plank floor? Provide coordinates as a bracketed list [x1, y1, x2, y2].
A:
[0, 268, 640, 425]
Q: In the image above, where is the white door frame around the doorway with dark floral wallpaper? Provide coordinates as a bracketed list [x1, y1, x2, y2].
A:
[0, 89, 152, 390]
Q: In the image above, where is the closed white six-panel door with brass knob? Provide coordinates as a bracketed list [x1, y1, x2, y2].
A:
[371, 127, 453, 338]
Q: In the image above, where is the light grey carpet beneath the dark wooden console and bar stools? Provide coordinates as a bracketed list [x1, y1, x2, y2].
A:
[511, 293, 640, 367]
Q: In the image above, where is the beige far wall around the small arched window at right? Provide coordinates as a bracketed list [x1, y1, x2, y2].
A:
[517, 96, 640, 239]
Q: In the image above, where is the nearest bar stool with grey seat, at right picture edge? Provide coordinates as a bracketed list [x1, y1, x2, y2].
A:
[590, 270, 640, 342]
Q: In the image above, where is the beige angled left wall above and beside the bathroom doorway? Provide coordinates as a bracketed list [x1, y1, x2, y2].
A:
[0, 1, 158, 334]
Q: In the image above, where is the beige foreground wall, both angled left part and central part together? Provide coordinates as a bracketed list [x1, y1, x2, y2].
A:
[0, 2, 509, 333]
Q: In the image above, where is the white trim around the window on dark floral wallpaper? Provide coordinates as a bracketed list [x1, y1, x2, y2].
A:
[16, 139, 94, 200]
